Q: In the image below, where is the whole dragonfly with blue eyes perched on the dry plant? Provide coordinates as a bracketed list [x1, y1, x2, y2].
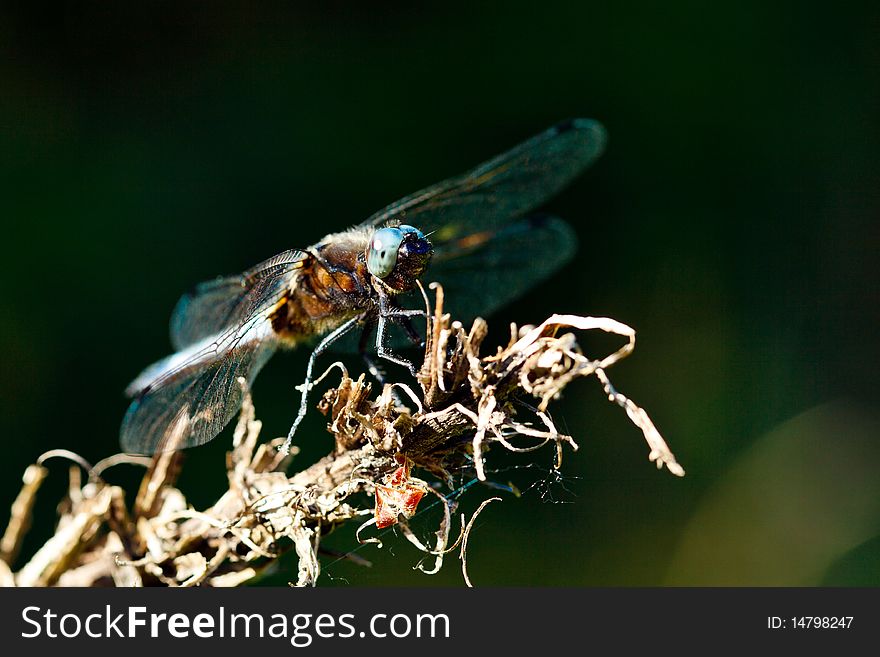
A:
[120, 119, 606, 454]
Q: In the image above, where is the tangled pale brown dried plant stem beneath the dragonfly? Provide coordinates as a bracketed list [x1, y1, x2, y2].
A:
[0, 288, 684, 586]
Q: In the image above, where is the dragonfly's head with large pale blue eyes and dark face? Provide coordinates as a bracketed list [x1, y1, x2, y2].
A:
[366, 224, 434, 292]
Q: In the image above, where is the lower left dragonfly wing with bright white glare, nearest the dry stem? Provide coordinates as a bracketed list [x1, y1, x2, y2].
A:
[120, 322, 275, 454]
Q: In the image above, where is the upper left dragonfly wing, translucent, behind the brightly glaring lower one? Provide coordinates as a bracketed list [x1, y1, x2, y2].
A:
[168, 250, 308, 352]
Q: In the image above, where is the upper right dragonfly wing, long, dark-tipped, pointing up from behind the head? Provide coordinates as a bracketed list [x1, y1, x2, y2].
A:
[364, 119, 606, 238]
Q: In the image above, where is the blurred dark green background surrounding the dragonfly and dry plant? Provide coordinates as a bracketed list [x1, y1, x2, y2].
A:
[0, 0, 880, 586]
